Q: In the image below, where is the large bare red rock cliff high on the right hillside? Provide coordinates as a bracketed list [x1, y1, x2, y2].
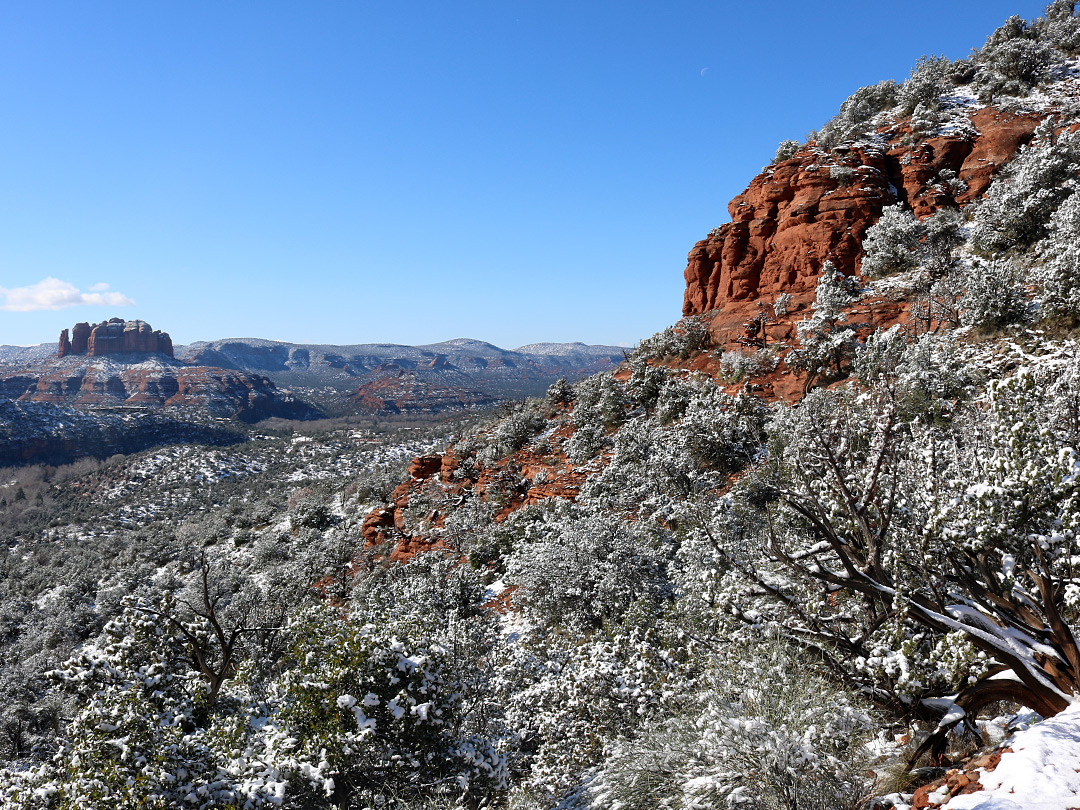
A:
[683, 108, 1039, 332]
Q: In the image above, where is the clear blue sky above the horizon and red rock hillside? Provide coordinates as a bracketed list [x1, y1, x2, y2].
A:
[0, 0, 1044, 348]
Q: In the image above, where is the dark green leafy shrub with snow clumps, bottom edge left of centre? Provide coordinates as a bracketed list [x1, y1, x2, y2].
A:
[273, 591, 508, 807]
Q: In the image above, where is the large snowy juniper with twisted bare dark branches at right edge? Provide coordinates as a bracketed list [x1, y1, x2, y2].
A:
[708, 361, 1080, 760]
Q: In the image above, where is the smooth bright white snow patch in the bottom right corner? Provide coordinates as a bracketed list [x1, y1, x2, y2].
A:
[943, 703, 1080, 810]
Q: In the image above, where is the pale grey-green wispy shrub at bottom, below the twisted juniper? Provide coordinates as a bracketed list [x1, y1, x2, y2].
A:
[588, 642, 875, 810]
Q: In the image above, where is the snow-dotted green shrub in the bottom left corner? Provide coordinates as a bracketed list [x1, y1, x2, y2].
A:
[6, 606, 273, 810]
